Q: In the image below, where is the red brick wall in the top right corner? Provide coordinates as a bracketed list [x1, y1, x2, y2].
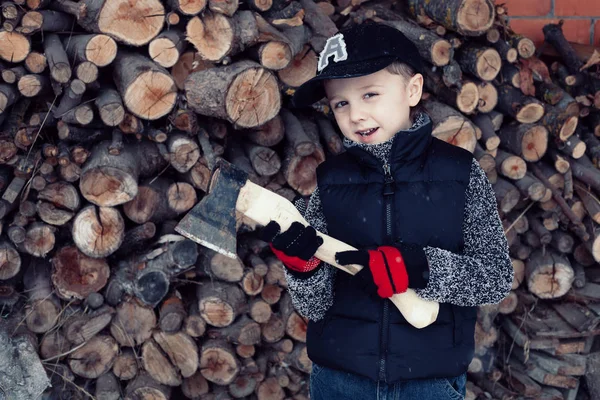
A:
[506, 0, 600, 46]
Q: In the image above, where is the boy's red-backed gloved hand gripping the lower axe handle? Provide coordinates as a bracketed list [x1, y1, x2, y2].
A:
[335, 246, 408, 298]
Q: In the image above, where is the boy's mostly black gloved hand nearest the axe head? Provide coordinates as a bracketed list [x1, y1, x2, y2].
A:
[260, 221, 323, 273]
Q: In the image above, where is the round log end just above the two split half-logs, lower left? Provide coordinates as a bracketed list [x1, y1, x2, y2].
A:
[110, 299, 157, 347]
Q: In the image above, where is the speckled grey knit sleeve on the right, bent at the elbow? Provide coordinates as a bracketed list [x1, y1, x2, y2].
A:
[416, 159, 513, 306]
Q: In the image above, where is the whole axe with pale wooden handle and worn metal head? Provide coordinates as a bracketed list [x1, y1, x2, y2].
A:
[175, 159, 439, 328]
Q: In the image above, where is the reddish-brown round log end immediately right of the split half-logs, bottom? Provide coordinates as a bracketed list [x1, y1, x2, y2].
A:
[199, 340, 240, 385]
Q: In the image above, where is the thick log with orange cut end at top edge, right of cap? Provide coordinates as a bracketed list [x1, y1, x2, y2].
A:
[408, 0, 495, 36]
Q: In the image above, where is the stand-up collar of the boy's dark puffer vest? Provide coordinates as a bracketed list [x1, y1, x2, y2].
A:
[346, 113, 433, 167]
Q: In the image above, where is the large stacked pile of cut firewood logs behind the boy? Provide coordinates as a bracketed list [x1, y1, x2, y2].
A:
[0, 0, 600, 400]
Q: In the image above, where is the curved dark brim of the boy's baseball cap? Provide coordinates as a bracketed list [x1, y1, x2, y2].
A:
[292, 57, 396, 108]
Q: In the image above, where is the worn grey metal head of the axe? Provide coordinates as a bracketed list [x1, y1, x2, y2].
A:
[175, 159, 248, 258]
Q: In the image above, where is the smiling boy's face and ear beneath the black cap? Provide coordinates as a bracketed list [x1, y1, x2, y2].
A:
[324, 69, 423, 144]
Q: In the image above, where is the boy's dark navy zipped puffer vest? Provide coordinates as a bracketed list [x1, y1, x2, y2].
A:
[307, 117, 476, 383]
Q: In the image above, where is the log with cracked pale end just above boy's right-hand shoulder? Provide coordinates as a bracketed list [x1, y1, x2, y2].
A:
[423, 98, 477, 153]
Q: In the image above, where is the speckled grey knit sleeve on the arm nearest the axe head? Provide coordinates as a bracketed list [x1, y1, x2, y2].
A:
[284, 188, 336, 321]
